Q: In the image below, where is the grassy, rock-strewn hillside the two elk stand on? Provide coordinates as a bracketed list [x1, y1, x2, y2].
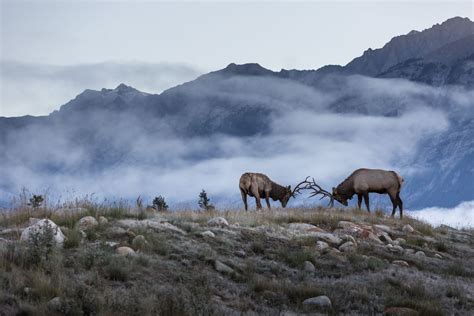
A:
[0, 205, 474, 315]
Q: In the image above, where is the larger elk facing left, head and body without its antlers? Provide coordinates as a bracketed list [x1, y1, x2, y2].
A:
[332, 169, 404, 218]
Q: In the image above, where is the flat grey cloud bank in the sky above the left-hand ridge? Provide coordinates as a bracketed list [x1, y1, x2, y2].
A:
[0, 61, 201, 116]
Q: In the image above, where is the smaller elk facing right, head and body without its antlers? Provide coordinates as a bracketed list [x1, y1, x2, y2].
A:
[239, 172, 293, 210]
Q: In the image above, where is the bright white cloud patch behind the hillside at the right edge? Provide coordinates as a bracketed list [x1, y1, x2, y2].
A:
[408, 201, 474, 228]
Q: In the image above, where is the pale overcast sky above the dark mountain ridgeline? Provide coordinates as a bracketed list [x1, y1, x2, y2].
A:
[0, 0, 473, 116]
